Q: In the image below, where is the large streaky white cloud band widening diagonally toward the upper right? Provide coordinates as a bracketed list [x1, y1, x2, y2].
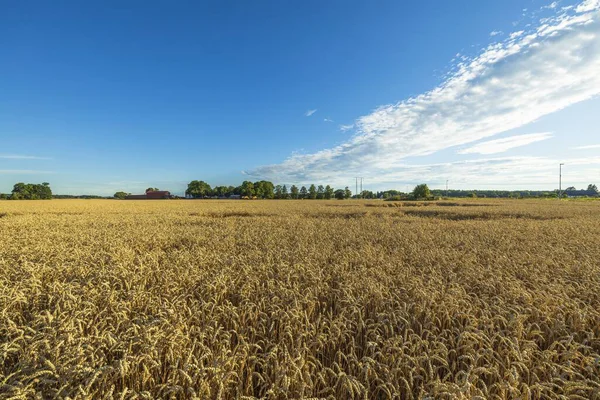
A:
[247, 0, 600, 188]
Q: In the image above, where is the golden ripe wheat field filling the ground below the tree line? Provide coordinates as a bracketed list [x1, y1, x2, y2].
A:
[0, 199, 600, 399]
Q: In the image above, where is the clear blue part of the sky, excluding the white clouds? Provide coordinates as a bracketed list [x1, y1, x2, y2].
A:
[0, 0, 600, 195]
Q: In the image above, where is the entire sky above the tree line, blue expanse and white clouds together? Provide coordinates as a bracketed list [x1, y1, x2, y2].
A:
[0, 0, 600, 195]
